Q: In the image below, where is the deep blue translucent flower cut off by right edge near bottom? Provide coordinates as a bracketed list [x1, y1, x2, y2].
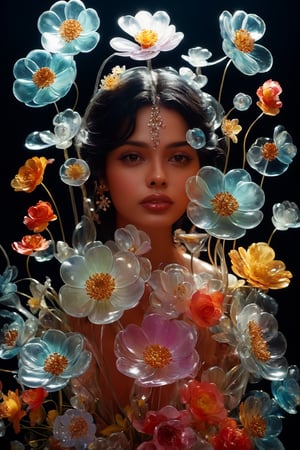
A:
[271, 366, 300, 414]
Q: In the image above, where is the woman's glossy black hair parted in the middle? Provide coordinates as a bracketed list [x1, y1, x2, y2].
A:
[77, 67, 223, 242]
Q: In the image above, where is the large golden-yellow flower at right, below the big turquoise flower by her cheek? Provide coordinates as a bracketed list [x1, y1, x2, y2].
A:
[228, 242, 293, 290]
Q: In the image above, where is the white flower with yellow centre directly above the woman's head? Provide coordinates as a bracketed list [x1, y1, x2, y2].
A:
[110, 11, 184, 61]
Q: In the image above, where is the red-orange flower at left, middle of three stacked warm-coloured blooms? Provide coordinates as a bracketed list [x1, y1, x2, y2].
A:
[23, 200, 57, 233]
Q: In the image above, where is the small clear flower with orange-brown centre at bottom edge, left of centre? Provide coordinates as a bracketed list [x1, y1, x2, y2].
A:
[53, 409, 96, 450]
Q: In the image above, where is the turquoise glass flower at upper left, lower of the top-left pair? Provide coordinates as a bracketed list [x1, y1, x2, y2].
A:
[13, 50, 77, 108]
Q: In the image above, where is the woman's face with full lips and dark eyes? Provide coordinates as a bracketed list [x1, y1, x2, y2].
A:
[105, 106, 200, 230]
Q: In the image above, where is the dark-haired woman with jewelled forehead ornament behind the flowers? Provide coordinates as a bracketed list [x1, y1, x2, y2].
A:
[63, 67, 232, 427]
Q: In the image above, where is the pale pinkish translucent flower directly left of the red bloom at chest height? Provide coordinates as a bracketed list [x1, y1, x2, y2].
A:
[149, 264, 196, 318]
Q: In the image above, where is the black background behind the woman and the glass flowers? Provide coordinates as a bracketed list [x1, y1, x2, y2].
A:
[0, 0, 300, 450]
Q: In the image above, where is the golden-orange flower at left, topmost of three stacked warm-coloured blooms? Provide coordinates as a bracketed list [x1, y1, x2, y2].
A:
[10, 156, 54, 194]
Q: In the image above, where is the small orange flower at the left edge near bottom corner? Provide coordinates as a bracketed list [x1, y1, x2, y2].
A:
[0, 389, 26, 433]
